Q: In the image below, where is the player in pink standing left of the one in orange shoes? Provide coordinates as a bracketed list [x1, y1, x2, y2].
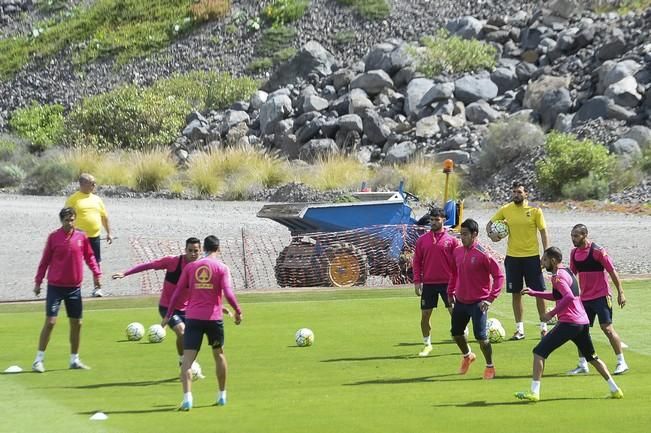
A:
[412, 208, 459, 356]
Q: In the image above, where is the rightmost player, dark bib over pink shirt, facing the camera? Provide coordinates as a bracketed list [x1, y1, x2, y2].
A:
[568, 224, 628, 375]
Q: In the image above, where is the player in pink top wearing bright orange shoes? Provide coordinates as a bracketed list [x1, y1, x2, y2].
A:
[448, 219, 504, 380]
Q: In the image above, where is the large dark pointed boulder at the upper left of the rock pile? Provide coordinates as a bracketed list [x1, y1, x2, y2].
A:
[263, 41, 337, 91]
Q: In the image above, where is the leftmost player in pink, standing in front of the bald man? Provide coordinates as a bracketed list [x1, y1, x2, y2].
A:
[32, 207, 102, 373]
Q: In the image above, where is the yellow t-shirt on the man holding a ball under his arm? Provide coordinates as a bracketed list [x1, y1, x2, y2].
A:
[491, 200, 547, 257]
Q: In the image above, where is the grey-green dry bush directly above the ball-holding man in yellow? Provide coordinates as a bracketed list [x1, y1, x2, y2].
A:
[475, 119, 545, 178]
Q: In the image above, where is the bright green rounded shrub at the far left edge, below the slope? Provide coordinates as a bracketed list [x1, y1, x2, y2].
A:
[9, 102, 64, 153]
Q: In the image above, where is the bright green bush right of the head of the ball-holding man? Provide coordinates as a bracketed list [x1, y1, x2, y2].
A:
[536, 132, 615, 198]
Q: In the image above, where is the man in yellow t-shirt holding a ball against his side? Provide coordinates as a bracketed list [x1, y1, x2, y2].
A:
[486, 181, 549, 340]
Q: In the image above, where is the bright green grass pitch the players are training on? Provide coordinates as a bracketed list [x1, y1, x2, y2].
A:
[0, 281, 651, 433]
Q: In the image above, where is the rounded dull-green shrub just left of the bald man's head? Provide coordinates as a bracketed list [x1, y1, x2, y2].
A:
[25, 158, 76, 195]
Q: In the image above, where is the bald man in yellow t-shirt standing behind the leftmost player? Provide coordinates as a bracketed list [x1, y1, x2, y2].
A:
[65, 173, 113, 297]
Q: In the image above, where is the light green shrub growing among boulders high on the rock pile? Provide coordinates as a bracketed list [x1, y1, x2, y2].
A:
[409, 29, 497, 77]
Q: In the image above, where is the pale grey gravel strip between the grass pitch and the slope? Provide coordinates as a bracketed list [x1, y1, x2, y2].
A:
[0, 194, 651, 301]
